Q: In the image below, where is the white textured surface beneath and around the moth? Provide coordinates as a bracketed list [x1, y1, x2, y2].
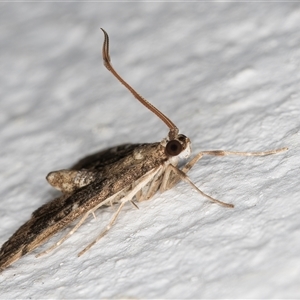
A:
[0, 3, 300, 299]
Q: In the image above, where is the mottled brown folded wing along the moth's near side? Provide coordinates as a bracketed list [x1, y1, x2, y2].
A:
[0, 143, 166, 271]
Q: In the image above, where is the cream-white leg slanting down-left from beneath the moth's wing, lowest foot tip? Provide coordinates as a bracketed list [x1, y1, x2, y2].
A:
[78, 166, 162, 256]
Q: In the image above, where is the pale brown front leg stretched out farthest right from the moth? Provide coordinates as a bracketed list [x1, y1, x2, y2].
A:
[168, 147, 288, 189]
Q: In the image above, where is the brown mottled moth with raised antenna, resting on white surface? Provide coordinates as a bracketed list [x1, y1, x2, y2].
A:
[0, 29, 287, 271]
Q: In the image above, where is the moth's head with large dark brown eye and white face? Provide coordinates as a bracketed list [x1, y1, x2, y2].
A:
[163, 134, 192, 158]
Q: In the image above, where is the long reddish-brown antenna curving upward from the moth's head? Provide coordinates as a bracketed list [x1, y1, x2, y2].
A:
[101, 28, 179, 140]
